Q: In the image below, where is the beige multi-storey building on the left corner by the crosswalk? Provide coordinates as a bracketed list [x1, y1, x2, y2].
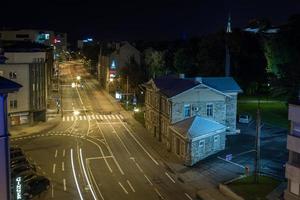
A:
[0, 43, 53, 125]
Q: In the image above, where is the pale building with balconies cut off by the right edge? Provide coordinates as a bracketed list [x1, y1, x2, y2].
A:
[284, 100, 300, 200]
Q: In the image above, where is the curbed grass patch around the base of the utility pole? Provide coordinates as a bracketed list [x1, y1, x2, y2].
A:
[228, 176, 280, 200]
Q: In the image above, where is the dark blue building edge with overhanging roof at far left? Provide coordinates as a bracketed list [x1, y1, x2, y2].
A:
[0, 76, 22, 200]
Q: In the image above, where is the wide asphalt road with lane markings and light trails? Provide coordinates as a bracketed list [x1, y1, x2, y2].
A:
[12, 61, 193, 200]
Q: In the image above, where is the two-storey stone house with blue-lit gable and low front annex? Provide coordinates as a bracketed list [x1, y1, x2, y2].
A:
[145, 76, 241, 165]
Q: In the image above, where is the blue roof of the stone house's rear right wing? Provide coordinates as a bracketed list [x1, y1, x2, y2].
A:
[201, 77, 242, 93]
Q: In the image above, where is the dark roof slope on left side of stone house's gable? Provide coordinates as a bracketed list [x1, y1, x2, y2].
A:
[153, 75, 200, 97]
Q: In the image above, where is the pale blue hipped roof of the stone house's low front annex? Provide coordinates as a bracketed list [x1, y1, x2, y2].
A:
[172, 115, 226, 139]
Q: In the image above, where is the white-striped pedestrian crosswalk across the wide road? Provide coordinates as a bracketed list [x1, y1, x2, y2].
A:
[62, 114, 124, 122]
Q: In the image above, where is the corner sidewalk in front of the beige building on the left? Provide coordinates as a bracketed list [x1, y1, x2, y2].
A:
[9, 118, 60, 138]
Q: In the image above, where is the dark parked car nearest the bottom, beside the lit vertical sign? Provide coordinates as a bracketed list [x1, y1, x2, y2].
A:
[23, 176, 50, 199]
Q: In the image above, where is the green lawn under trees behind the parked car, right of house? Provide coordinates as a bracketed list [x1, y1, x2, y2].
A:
[237, 101, 289, 128]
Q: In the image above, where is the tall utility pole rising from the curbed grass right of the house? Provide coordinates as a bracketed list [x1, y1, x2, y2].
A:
[254, 100, 261, 183]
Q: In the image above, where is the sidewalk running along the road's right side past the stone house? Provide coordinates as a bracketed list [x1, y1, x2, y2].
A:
[103, 91, 229, 200]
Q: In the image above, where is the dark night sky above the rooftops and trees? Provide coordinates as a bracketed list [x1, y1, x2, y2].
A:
[0, 0, 300, 40]
